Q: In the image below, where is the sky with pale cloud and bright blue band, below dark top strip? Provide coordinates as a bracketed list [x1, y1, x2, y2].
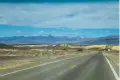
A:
[0, 0, 119, 37]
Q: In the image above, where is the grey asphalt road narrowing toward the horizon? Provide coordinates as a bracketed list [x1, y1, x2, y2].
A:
[0, 53, 116, 80]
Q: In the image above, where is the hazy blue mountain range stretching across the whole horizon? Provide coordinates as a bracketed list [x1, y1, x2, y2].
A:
[0, 35, 119, 45]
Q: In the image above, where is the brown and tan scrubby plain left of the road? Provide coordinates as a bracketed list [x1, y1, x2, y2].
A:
[0, 44, 100, 70]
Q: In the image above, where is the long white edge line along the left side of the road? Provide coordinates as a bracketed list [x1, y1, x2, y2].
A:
[0, 56, 78, 76]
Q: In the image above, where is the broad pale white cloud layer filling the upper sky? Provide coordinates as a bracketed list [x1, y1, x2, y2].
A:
[0, 3, 119, 28]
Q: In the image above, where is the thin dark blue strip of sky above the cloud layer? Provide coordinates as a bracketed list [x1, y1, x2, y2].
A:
[0, 0, 119, 3]
